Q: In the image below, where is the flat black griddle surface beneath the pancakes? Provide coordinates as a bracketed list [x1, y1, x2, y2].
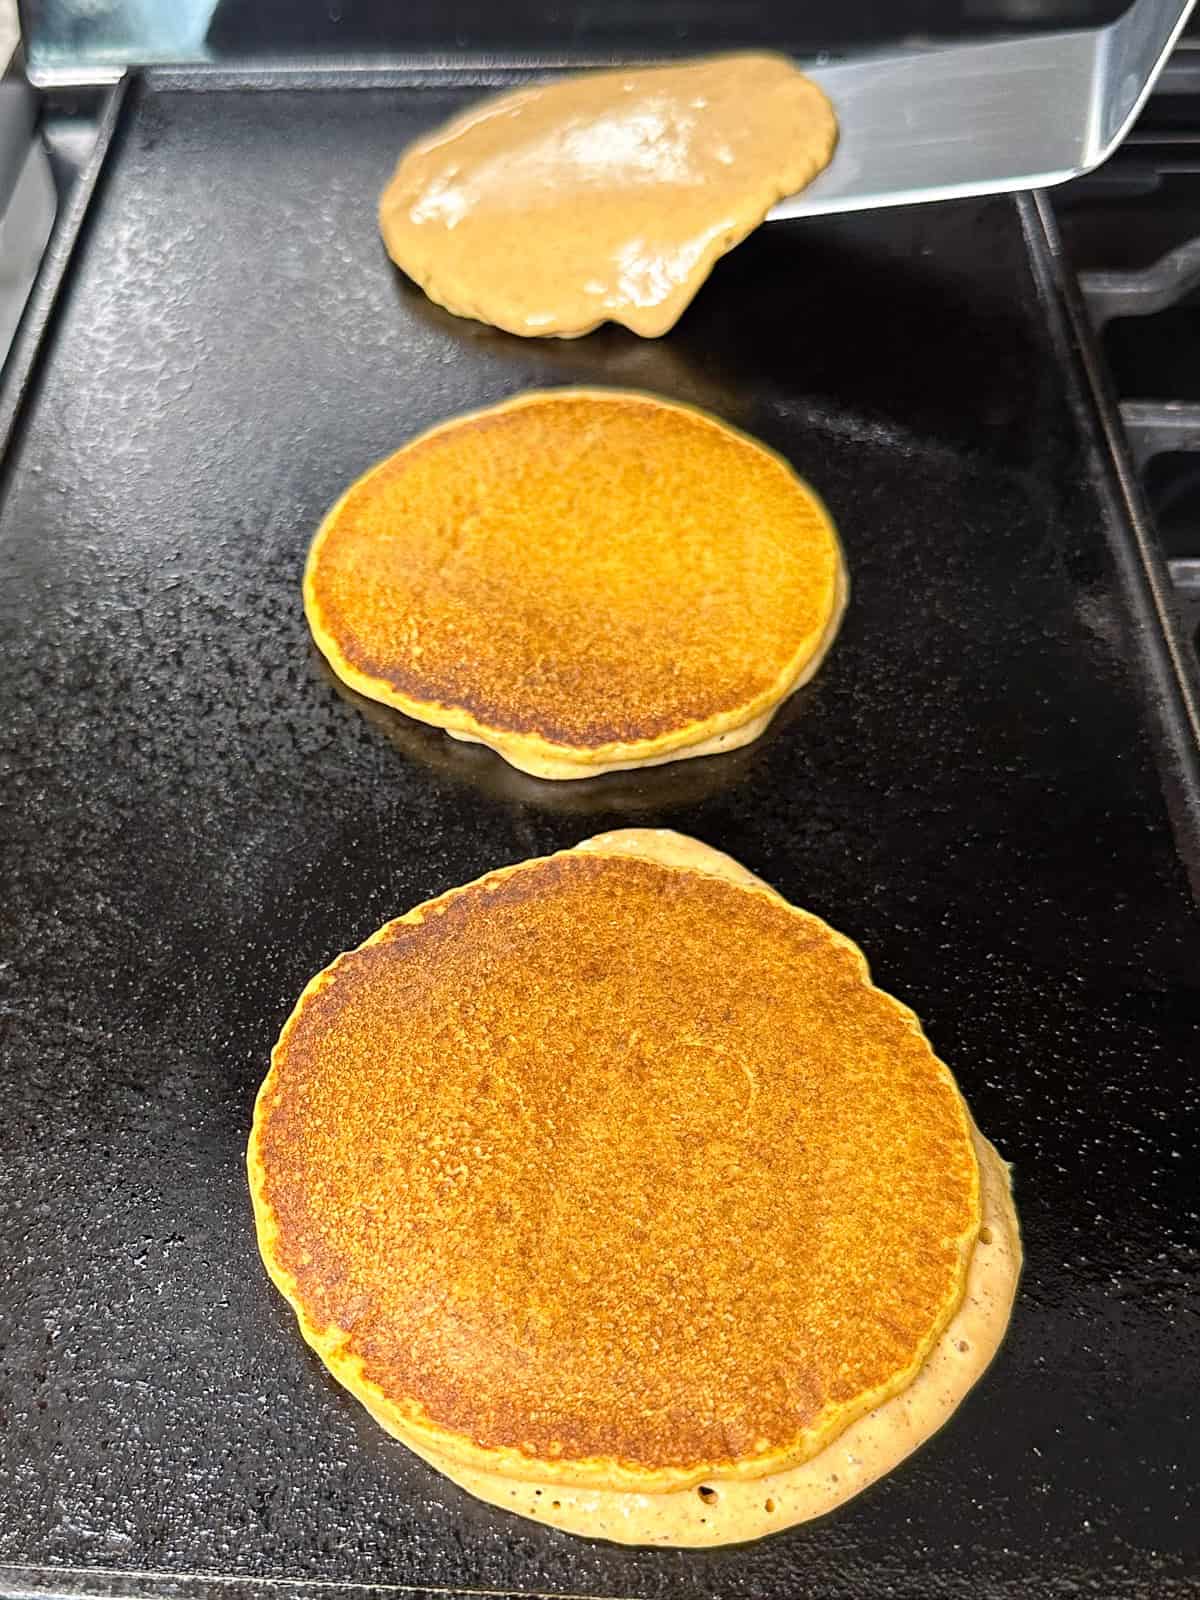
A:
[0, 69, 1200, 1600]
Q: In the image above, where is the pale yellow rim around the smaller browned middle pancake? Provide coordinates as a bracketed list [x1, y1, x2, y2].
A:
[302, 386, 850, 781]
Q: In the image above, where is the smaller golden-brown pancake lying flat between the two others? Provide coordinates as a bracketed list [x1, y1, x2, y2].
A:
[304, 389, 846, 779]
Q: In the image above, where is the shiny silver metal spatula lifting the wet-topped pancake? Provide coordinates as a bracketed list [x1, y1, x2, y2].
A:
[771, 0, 1195, 219]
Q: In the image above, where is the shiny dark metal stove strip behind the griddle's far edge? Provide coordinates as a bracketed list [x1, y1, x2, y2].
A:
[18, 0, 1128, 83]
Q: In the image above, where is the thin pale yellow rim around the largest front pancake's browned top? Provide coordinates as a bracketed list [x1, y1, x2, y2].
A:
[246, 829, 981, 1494]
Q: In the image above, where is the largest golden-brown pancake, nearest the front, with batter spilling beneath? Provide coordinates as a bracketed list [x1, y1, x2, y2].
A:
[250, 829, 1021, 1544]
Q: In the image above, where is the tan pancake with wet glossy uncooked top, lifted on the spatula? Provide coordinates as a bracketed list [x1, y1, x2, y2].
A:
[379, 54, 837, 338]
